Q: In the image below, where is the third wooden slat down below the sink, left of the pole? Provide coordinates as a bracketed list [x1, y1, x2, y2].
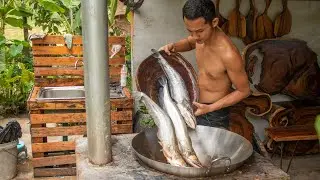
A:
[31, 126, 87, 137]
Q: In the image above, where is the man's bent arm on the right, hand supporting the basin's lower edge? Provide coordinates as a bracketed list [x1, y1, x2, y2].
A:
[194, 52, 250, 116]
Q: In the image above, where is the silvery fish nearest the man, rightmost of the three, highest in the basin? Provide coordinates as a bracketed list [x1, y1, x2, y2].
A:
[151, 49, 197, 129]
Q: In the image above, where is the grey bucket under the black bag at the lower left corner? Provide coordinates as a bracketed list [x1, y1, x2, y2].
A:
[0, 140, 18, 180]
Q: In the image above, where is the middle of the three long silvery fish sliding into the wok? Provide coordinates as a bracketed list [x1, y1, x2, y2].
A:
[158, 76, 202, 168]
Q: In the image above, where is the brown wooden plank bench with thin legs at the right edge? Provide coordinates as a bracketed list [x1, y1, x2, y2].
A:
[266, 125, 318, 172]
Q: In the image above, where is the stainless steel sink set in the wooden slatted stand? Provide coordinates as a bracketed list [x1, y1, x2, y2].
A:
[36, 86, 125, 100]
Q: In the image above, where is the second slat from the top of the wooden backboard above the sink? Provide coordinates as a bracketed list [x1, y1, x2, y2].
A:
[32, 46, 125, 56]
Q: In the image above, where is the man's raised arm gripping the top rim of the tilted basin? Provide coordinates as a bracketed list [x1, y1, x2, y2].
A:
[160, 36, 196, 55]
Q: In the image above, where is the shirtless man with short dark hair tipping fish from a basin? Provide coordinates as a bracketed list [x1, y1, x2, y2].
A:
[160, 0, 250, 129]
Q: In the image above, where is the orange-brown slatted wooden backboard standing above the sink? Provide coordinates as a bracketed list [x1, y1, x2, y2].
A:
[32, 36, 125, 87]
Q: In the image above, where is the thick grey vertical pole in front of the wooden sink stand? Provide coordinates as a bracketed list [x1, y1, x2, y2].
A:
[81, 0, 112, 165]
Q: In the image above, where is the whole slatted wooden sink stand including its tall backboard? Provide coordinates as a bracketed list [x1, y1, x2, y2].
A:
[28, 36, 133, 177]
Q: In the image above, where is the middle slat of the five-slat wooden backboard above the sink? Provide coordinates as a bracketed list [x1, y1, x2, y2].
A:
[33, 57, 125, 67]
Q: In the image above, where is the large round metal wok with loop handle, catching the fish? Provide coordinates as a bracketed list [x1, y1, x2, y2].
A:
[132, 125, 253, 177]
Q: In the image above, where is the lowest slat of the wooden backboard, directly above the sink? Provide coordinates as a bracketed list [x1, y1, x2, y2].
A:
[35, 74, 120, 87]
